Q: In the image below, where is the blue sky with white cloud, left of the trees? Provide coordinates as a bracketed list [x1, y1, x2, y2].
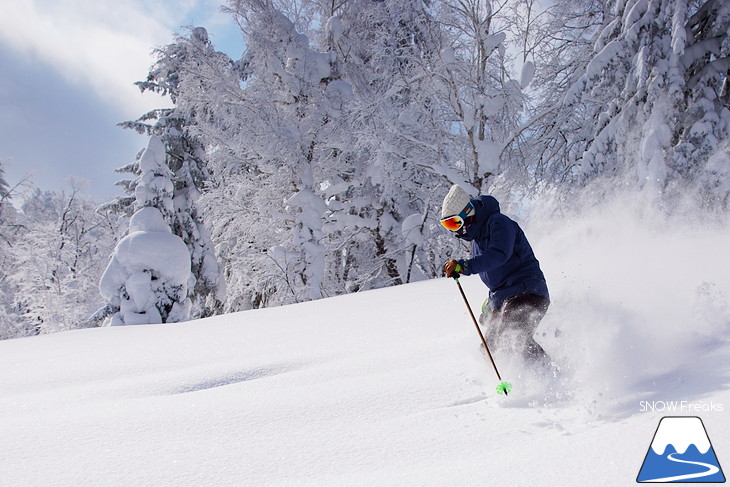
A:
[0, 0, 243, 203]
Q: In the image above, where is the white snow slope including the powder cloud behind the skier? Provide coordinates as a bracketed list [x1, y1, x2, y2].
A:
[0, 200, 730, 487]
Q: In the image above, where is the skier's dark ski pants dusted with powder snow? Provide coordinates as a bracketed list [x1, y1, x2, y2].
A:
[479, 294, 550, 365]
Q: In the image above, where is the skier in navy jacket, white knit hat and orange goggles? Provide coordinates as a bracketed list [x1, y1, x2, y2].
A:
[441, 184, 550, 367]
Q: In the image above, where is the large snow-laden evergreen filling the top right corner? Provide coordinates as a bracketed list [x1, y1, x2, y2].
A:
[552, 0, 730, 207]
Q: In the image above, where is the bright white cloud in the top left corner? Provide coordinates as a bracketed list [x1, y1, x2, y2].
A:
[0, 0, 217, 118]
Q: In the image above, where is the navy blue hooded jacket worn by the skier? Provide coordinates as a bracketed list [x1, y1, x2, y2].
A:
[458, 195, 550, 309]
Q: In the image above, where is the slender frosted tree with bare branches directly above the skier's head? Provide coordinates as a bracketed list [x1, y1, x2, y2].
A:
[424, 0, 525, 192]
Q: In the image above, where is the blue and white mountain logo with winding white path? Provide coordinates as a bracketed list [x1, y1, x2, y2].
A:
[636, 416, 725, 483]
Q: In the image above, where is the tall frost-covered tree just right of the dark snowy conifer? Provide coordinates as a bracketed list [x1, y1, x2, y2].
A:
[191, 1, 347, 306]
